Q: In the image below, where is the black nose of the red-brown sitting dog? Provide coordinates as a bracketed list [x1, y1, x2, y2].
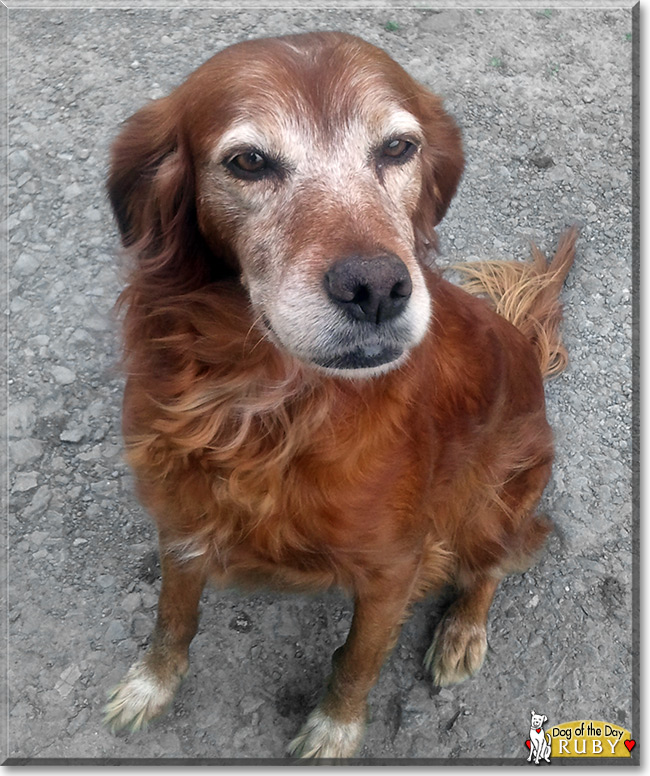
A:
[325, 254, 412, 324]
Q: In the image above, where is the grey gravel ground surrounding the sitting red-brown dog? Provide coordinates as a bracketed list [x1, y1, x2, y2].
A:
[4, 4, 640, 763]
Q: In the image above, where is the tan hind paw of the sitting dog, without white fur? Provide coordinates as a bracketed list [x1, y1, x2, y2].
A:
[424, 613, 487, 687]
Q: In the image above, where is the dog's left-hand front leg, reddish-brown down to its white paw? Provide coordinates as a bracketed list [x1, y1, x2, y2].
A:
[104, 542, 206, 730]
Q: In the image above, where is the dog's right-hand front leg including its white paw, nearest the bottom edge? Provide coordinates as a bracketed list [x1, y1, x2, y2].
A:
[289, 567, 416, 758]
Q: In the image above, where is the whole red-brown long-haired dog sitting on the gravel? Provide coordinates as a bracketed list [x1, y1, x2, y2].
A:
[106, 32, 575, 758]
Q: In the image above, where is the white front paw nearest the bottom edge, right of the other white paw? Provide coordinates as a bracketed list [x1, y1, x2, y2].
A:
[288, 707, 366, 757]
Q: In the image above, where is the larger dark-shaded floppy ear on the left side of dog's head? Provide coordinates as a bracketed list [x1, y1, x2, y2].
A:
[107, 97, 214, 292]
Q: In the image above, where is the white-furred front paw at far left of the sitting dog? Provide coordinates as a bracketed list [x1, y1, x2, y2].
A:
[104, 660, 181, 731]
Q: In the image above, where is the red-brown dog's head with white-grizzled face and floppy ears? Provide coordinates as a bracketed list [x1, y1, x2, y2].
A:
[108, 33, 463, 377]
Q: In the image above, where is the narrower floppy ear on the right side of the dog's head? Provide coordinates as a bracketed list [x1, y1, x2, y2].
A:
[414, 88, 465, 252]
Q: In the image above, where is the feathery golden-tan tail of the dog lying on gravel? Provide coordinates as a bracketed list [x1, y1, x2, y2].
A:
[454, 226, 578, 377]
